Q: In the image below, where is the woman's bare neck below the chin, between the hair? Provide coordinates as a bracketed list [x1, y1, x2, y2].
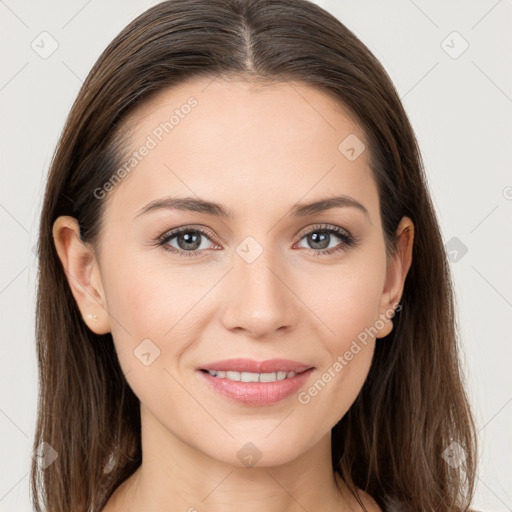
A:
[103, 408, 358, 512]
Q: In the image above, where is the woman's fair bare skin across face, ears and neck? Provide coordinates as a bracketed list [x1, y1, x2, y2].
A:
[53, 79, 414, 512]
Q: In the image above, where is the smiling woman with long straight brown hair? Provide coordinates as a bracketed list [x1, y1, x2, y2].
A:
[32, 0, 477, 512]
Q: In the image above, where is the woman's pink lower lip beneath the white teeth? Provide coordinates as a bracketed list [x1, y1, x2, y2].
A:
[199, 368, 314, 405]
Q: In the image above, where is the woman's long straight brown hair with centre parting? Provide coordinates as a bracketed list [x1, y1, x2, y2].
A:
[31, 0, 477, 512]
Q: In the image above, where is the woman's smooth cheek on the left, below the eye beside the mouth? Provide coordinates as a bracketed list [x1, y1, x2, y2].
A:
[105, 261, 192, 407]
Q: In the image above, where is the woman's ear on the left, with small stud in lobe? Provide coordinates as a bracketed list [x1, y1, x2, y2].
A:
[53, 215, 110, 334]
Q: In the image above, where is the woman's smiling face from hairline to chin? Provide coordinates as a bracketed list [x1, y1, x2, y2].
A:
[53, 79, 408, 466]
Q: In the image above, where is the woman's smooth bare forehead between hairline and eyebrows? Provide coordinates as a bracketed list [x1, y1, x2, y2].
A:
[104, 78, 378, 224]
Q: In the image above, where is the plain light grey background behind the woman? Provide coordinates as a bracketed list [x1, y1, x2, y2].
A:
[0, 0, 512, 512]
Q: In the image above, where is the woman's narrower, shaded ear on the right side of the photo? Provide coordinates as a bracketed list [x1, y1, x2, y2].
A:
[376, 217, 414, 338]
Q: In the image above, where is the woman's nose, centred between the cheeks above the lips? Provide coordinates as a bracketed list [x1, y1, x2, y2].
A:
[221, 244, 301, 338]
